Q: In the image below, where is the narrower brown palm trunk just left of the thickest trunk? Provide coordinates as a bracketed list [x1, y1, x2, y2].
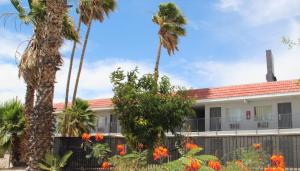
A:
[20, 83, 35, 163]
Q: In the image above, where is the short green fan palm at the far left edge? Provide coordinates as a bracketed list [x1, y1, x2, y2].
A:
[0, 99, 25, 166]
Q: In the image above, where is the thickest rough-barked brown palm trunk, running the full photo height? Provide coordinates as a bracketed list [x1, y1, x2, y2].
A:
[28, 0, 67, 171]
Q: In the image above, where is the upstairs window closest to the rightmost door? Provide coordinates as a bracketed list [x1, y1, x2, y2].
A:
[254, 105, 272, 121]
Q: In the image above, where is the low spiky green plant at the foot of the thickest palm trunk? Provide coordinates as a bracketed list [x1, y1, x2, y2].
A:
[39, 151, 73, 171]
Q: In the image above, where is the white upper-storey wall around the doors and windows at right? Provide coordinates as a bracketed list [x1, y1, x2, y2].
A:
[205, 96, 300, 131]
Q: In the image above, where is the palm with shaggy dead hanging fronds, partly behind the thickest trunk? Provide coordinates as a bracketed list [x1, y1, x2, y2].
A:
[11, 0, 79, 166]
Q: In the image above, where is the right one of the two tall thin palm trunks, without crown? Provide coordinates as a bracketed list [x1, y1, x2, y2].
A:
[72, 9, 94, 106]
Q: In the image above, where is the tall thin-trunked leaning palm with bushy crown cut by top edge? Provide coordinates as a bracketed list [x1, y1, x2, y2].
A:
[72, 0, 117, 105]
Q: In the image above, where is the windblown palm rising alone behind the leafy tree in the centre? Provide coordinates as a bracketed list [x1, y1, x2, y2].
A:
[152, 3, 186, 82]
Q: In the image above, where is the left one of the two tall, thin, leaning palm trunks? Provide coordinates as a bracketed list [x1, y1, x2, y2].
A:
[65, 16, 81, 109]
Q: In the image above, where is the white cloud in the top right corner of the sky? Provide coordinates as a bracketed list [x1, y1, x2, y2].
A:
[217, 0, 300, 25]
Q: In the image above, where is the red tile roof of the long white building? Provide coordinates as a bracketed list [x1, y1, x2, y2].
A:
[54, 80, 300, 111]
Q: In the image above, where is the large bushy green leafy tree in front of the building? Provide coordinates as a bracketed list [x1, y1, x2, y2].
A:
[111, 69, 194, 148]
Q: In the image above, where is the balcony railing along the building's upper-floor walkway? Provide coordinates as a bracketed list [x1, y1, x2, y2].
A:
[90, 114, 300, 134]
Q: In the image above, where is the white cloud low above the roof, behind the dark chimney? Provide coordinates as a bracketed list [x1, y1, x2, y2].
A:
[190, 20, 300, 86]
